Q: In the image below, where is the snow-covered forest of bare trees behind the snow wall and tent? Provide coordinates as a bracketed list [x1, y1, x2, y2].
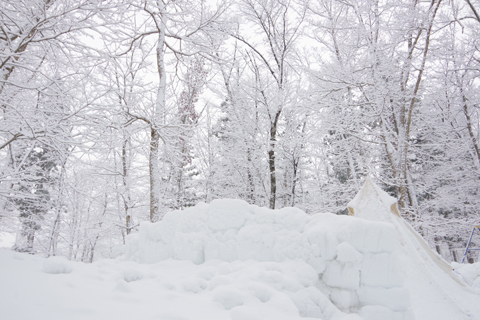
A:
[0, 0, 480, 262]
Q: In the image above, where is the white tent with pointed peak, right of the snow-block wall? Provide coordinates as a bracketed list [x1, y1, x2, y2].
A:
[348, 179, 480, 319]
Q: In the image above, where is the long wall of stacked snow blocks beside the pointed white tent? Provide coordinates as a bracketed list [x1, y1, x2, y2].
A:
[125, 199, 414, 320]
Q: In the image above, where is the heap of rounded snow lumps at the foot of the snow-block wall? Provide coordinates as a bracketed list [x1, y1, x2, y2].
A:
[202, 260, 342, 320]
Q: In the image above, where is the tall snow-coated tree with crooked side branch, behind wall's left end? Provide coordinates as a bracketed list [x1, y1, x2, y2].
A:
[116, 0, 226, 221]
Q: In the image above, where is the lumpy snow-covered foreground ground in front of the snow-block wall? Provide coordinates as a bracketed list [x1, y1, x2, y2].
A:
[0, 249, 338, 320]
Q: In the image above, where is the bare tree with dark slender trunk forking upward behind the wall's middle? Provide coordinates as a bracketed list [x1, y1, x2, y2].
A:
[233, 0, 306, 209]
